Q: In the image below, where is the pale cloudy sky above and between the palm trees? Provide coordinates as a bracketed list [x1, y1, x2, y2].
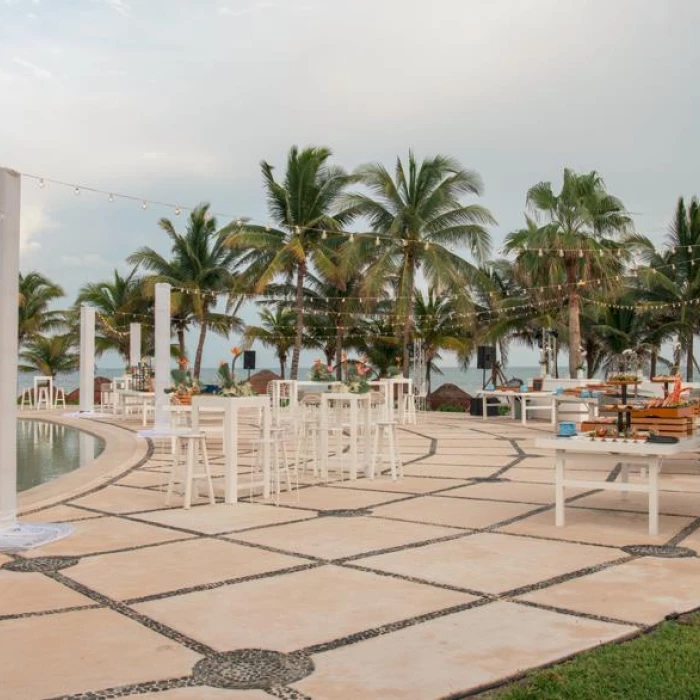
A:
[0, 0, 700, 366]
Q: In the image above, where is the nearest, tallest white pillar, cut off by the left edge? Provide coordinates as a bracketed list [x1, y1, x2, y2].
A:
[0, 168, 21, 531]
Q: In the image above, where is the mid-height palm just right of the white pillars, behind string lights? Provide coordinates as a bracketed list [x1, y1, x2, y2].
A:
[127, 204, 241, 379]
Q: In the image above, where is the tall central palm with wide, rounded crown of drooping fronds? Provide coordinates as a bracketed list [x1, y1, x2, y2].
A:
[342, 152, 494, 377]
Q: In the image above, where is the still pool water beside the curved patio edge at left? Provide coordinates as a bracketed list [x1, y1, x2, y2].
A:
[17, 420, 105, 491]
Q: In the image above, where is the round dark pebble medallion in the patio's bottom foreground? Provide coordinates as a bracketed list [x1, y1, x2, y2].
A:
[192, 649, 314, 689]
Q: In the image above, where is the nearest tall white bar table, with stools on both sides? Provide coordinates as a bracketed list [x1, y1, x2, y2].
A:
[192, 394, 272, 503]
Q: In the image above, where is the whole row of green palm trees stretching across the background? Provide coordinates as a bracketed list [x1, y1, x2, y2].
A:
[19, 147, 700, 392]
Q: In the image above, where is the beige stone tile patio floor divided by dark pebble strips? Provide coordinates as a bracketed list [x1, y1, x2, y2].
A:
[0, 414, 700, 700]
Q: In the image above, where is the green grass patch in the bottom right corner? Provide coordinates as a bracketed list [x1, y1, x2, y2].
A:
[490, 613, 700, 700]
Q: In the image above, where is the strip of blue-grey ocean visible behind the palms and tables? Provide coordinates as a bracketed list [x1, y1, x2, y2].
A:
[17, 366, 539, 395]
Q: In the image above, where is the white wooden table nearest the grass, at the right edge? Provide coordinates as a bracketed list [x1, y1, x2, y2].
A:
[535, 436, 700, 537]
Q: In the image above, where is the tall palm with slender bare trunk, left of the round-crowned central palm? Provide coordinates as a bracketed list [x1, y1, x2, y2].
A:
[228, 146, 350, 379]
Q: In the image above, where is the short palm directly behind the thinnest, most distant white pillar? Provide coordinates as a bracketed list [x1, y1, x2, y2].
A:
[75, 269, 153, 364]
